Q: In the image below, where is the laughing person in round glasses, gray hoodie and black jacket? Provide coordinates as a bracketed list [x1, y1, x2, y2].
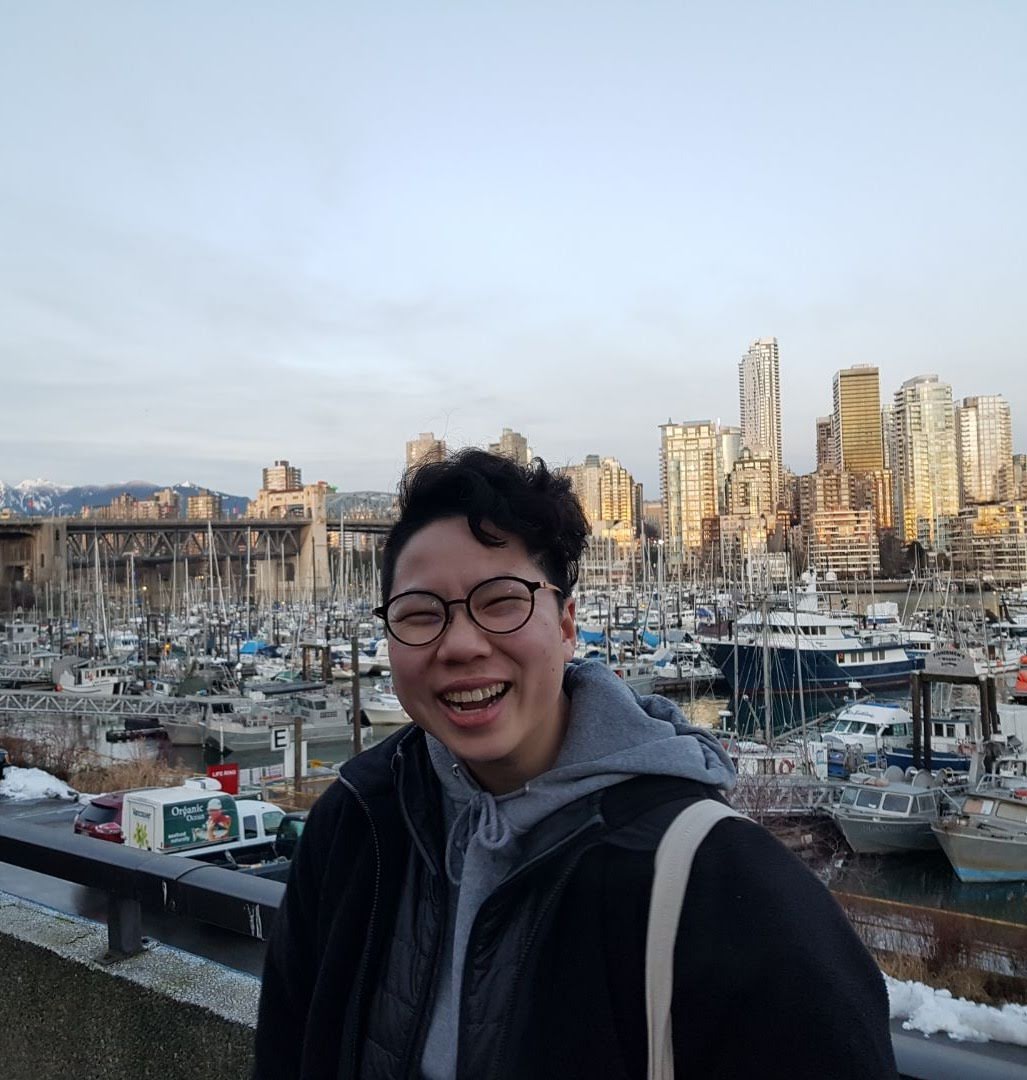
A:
[255, 450, 895, 1080]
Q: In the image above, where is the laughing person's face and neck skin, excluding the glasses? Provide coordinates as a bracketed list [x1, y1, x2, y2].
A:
[389, 517, 575, 793]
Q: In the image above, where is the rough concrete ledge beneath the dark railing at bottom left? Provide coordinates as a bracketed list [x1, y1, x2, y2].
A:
[0, 893, 260, 1080]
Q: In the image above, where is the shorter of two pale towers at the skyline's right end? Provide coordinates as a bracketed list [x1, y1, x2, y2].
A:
[956, 394, 1013, 507]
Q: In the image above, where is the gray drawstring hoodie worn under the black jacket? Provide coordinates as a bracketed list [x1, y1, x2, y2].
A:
[421, 661, 734, 1080]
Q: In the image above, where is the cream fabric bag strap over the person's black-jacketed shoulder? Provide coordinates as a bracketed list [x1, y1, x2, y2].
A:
[646, 799, 745, 1080]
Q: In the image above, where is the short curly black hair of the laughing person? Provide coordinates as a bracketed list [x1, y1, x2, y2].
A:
[381, 448, 590, 604]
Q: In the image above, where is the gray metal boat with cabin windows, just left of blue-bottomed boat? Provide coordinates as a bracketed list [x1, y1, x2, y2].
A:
[829, 766, 942, 855]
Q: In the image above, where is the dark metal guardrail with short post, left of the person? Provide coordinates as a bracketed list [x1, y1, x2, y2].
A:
[0, 821, 285, 958]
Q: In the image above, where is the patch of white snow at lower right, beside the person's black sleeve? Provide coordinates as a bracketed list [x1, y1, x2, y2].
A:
[884, 975, 1027, 1047]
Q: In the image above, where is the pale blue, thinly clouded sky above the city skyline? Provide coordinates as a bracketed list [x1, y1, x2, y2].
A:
[0, 0, 1027, 497]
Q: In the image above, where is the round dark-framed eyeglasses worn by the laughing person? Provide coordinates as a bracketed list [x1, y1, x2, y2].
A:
[375, 577, 564, 646]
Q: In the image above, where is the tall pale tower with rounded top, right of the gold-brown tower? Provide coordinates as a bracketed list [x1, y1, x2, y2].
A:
[892, 375, 959, 546]
